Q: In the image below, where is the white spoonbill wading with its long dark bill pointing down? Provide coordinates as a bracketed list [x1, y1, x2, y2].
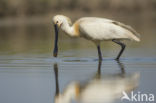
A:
[53, 15, 140, 61]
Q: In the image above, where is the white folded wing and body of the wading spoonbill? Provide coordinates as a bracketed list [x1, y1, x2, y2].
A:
[79, 18, 140, 41]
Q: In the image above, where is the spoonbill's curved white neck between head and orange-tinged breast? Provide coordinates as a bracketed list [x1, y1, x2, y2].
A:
[61, 22, 78, 37]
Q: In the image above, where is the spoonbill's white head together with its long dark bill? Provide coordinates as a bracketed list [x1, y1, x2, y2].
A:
[53, 15, 71, 57]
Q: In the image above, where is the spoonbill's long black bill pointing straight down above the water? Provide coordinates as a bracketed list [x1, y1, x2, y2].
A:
[53, 24, 58, 57]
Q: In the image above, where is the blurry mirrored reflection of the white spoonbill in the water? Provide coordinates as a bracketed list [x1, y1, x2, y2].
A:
[54, 62, 139, 103]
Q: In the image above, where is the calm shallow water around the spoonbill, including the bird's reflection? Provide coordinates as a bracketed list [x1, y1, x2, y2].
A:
[0, 17, 156, 103]
